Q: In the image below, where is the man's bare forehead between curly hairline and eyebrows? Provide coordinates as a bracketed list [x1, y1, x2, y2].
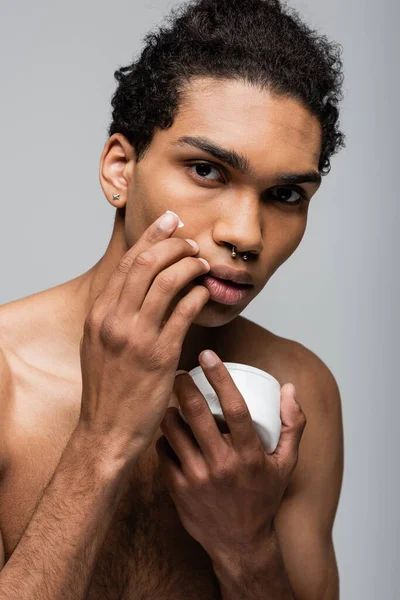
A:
[169, 78, 322, 161]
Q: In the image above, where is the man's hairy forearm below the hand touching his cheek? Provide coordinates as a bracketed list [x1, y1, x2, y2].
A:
[0, 349, 128, 600]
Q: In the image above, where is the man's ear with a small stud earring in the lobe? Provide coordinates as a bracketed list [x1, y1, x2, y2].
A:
[99, 133, 136, 208]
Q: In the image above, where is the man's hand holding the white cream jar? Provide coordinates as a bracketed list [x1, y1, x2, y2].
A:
[157, 351, 306, 562]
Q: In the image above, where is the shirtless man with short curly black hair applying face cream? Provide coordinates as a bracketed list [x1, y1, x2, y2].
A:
[0, 0, 343, 600]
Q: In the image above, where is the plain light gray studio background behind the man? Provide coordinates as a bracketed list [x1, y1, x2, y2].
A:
[0, 0, 400, 600]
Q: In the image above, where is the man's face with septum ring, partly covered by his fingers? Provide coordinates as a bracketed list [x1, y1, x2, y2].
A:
[125, 78, 321, 327]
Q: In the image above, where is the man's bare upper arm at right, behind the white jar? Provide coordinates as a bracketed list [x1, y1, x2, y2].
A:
[274, 345, 344, 600]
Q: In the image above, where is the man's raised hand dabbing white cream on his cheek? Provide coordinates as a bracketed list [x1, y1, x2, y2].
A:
[76, 215, 210, 471]
